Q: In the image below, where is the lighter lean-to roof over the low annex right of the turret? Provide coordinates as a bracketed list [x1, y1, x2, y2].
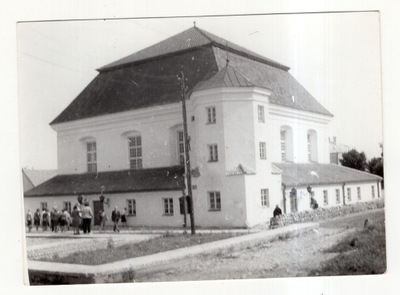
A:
[274, 163, 382, 186]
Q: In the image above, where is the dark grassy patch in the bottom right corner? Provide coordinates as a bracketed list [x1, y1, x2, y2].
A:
[310, 214, 386, 276]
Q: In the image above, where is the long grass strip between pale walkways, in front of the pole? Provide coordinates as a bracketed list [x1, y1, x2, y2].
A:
[41, 232, 240, 265]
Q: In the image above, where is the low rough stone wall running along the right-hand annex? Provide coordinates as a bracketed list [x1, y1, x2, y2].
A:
[271, 199, 385, 225]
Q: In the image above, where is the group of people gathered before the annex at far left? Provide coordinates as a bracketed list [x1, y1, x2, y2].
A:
[26, 200, 126, 235]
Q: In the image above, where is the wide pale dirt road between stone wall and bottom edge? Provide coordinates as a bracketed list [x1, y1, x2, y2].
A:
[135, 211, 383, 282]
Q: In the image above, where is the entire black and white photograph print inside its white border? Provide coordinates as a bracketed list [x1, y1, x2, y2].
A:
[17, 11, 387, 285]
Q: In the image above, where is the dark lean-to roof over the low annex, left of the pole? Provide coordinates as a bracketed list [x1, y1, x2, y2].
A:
[24, 166, 185, 197]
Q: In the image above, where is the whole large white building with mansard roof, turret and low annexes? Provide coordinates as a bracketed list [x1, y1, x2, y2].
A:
[24, 27, 380, 227]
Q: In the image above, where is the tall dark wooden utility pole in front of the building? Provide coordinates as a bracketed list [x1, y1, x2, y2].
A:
[178, 72, 196, 235]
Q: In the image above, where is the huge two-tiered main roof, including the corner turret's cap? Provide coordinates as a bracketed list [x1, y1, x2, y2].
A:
[50, 27, 332, 124]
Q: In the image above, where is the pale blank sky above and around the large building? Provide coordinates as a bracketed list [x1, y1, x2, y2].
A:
[17, 12, 382, 169]
